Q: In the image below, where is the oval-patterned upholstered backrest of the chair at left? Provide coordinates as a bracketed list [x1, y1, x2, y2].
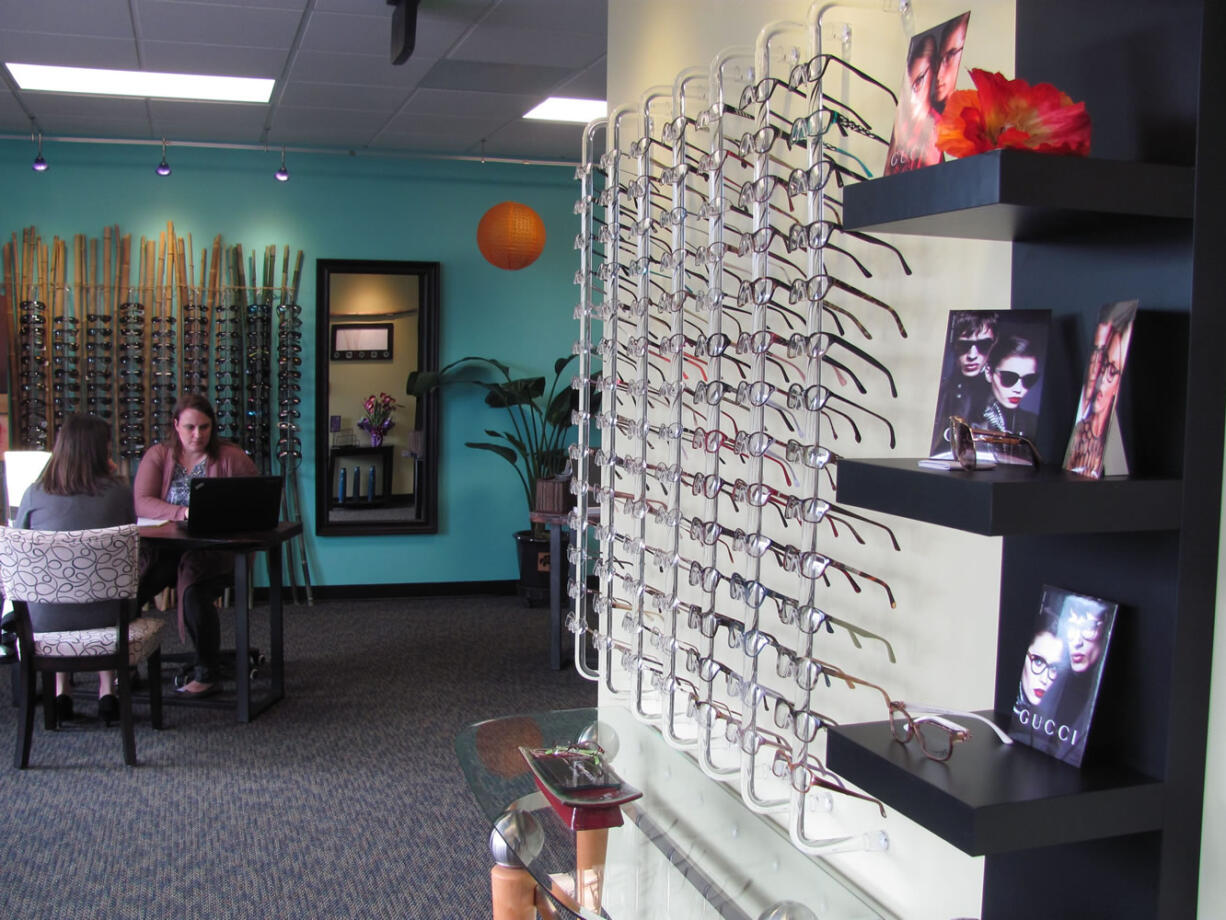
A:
[0, 524, 140, 604]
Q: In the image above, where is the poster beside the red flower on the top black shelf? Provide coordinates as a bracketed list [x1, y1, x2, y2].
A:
[885, 12, 971, 175]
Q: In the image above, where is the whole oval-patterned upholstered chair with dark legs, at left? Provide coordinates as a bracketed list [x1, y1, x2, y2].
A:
[0, 524, 163, 769]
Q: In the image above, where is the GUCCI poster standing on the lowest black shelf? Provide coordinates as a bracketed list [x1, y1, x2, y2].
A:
[1009, 585, 1117, 767]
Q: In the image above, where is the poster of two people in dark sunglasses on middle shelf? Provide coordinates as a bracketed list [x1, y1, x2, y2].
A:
[931, 310, 1051, 467]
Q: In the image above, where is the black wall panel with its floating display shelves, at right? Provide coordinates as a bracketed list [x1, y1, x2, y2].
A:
[828, 0, 1226, 920]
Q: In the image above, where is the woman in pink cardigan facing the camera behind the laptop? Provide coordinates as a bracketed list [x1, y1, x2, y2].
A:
[132, 393, 259, 697]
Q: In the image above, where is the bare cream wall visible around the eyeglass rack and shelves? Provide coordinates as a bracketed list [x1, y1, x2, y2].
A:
[602, 0, 1013, 920]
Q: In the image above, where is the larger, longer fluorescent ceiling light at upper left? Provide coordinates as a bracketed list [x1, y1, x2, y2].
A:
[5, 64, 276, 103]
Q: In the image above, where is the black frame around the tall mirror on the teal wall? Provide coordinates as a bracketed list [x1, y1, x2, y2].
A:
[315, 259, 441, 536]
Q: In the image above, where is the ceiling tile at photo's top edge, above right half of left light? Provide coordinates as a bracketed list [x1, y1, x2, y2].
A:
[140, 0, 302, 49]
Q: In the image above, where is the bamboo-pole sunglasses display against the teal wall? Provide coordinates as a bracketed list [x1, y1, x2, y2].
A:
[4, 223, 303, 483]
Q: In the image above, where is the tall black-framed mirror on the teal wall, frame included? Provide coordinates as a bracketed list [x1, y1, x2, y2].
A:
[315, 259, 439, 536]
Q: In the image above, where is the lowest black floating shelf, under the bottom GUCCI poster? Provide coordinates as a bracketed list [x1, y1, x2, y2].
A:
[826, 713, 1163, 856]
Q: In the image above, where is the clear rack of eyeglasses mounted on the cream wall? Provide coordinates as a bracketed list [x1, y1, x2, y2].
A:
[569, 18, 912, 854]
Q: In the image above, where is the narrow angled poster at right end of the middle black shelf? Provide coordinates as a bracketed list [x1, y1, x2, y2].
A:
[1064, 301, 1139, 480]
